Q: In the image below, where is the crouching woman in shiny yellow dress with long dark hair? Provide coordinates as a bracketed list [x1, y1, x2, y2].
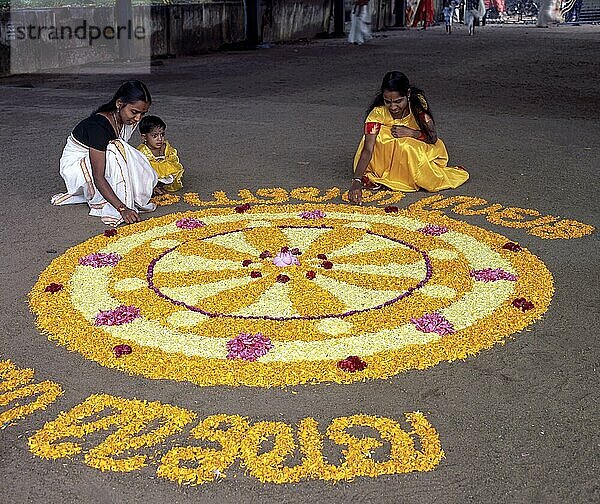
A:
[349, 72, 469, 203]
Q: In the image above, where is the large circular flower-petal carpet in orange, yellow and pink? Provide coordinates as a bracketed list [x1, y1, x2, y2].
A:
[30, 205, 553, 387]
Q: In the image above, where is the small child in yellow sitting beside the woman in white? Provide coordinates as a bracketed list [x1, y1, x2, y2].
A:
[138, 116, 183, 194]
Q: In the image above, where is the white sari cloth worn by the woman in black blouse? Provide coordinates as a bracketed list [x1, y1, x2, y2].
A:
[51, 125, 158, 226]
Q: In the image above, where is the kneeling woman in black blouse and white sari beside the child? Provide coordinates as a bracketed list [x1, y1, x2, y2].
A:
[52, 80, 158, 226]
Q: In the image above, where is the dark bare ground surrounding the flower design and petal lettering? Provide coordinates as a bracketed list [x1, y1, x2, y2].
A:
[0, 25, 600, 504]
